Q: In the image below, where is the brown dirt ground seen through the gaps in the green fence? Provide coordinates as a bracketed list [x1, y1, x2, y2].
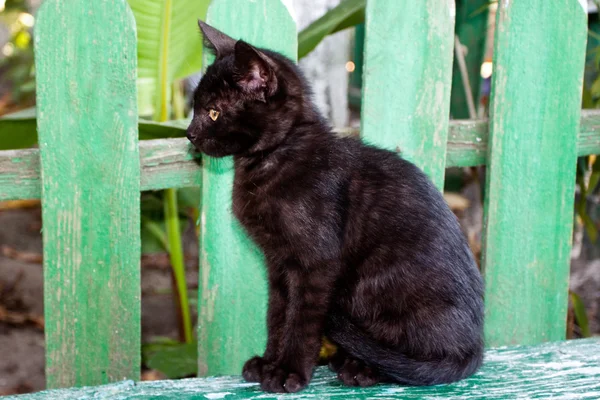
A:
[0, 190, 600, 395]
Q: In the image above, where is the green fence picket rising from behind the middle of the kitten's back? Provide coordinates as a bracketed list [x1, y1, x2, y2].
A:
[361, 0, 455, 189]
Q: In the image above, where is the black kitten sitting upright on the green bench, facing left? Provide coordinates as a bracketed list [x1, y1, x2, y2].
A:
[187, 22, 483, 392]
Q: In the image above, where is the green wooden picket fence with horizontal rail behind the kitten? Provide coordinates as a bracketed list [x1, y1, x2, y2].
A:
[0, 0, 600, 387]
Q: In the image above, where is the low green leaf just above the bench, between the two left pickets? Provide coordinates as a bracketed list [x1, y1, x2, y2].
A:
[142, 341, 198, 379]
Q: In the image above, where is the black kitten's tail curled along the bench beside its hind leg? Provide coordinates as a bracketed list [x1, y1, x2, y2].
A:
[327, 316, 483, 386]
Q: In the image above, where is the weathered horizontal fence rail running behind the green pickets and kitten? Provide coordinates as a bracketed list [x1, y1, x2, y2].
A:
[0, 110, 600, 201]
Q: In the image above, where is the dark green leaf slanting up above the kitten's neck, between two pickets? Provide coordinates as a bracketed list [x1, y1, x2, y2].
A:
[298, 0, 367, 58]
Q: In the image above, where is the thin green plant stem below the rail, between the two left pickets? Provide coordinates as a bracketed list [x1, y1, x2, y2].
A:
[164, 189, 194, 343]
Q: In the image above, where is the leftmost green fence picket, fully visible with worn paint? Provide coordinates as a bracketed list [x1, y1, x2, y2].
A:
[35, 0, 141, 387]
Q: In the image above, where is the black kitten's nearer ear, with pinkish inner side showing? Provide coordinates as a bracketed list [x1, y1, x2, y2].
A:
[235, 40, 277, 101]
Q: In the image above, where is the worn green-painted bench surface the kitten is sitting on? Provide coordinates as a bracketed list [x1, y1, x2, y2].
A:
[13, 338, 600, 400]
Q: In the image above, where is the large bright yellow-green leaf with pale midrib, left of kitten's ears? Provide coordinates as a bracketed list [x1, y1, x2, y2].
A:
[128, 0, 210, 120]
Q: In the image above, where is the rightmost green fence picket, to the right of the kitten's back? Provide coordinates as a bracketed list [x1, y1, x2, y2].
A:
[482, 0, 587, 346]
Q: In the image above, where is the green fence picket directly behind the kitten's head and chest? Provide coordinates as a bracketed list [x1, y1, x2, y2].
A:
[198, 0, 297, 375]
